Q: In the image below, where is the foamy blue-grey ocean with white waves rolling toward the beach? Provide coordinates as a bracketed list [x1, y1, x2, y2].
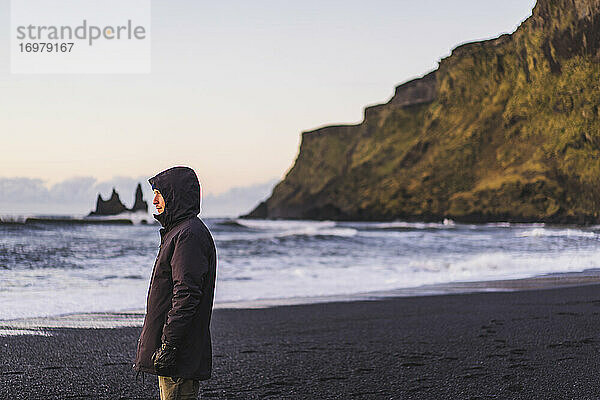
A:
[0, 218, 600, 320]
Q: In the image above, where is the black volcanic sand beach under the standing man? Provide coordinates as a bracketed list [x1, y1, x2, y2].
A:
[0, 285, 600, 399]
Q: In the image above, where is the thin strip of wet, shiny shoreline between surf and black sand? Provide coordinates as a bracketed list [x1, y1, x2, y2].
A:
[0, 269, 600, 337]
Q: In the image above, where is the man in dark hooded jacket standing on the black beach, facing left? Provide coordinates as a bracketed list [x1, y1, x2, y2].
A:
[134, 167, 217, 400]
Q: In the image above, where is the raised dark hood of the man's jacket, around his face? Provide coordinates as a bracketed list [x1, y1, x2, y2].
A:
[148, 167, 200, 229]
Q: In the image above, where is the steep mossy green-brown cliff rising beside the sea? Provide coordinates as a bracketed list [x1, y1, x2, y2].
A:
[246, 0, 600, 223]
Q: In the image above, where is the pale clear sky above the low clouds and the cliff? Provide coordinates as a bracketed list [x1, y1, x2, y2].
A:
[0, 0, 535, 194]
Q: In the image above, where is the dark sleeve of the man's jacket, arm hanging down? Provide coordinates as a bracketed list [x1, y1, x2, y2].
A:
[162, 232, 208, 347]
